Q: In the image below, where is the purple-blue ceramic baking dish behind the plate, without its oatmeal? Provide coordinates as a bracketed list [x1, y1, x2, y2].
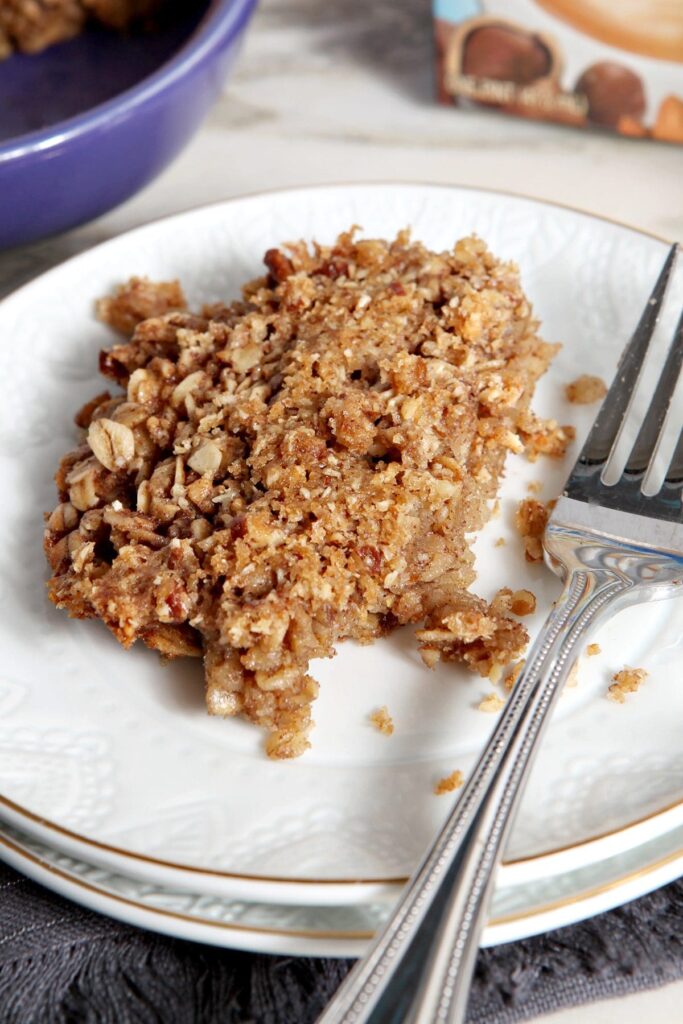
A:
[0, 0, 256, 249]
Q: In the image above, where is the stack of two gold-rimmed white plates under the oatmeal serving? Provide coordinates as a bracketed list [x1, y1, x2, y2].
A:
[0, 184, 683, 956]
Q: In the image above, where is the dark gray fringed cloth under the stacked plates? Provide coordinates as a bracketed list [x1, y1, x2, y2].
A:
[0, 864, 683, 1024]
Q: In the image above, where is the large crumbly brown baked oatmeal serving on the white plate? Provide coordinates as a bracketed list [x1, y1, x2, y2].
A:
[45, 231, 569, 758]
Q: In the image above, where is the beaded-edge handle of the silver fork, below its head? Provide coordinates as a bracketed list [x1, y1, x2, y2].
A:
[318, 568, 631, 1024]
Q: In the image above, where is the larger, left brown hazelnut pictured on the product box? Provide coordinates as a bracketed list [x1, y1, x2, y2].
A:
[461, 25, 553, 85]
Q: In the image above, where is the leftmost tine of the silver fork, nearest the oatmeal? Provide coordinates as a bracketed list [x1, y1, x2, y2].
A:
[577, 243, 678, 468]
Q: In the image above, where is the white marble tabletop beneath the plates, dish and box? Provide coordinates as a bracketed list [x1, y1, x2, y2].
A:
[5, 0, 683, 1024]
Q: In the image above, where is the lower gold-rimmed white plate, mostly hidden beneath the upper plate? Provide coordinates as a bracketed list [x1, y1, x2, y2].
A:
[0, 811, 683, 956]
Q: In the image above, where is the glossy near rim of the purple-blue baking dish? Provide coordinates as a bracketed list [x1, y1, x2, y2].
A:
[0, 0, 257, 164]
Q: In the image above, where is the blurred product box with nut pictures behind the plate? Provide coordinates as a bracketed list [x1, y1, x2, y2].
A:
[433, 0, 683, 142]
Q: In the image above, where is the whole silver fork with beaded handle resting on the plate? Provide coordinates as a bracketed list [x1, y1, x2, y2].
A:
[318, 246, 683, 1024]
